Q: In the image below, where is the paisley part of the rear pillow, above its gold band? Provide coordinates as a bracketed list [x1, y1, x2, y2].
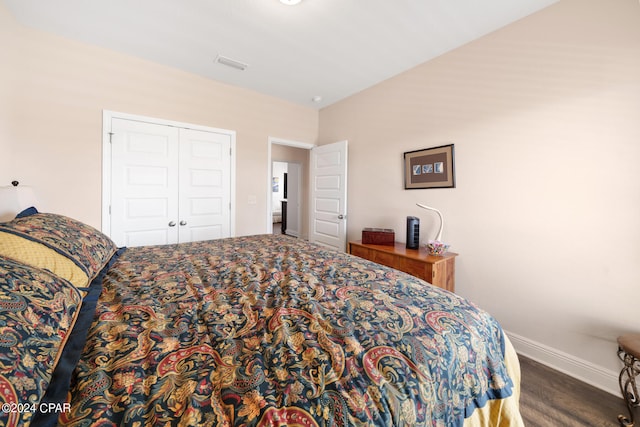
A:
[0, 213, 118, 286]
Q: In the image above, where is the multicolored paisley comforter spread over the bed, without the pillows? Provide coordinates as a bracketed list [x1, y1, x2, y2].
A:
[59, 235, 522, 427]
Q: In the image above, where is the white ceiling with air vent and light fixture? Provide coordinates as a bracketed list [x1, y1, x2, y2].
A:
[0, 0, 558, 108]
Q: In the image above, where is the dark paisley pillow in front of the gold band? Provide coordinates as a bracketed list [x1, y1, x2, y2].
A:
[0, 257, 82, 425]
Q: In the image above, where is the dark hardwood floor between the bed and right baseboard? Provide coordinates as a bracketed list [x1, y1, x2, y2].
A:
[519, 356, 628, 427]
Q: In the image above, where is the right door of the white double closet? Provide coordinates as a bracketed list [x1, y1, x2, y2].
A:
[178, 129, 231, 242]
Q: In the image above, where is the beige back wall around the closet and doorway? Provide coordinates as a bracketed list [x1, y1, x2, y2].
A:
[0, 4, 318, 235]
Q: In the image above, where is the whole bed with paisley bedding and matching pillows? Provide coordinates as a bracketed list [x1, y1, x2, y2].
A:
[0, 209, 523, 427]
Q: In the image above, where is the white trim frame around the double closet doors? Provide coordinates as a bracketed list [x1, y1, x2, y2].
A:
[101, 110, 236, 236]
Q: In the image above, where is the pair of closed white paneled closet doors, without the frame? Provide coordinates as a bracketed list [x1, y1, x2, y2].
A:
[110, 118, 231, 246]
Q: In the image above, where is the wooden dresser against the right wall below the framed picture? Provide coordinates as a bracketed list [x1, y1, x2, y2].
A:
[348, 240, 458, 292]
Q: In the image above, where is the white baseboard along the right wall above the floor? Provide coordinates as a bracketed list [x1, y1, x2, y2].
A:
[505, 331, 620, 396]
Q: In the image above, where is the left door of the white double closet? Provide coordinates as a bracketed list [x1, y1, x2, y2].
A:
[110, 118, 179, 246]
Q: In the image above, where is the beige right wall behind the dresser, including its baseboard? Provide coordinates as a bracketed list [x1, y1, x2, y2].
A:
[319, 0, 640, 392]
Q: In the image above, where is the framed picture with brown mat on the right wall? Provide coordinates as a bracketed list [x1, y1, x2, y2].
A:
[404, 144, 456, 190]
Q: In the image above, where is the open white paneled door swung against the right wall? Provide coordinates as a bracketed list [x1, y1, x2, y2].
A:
[309, 141, 347, 251]
